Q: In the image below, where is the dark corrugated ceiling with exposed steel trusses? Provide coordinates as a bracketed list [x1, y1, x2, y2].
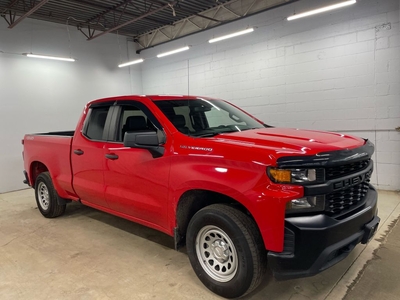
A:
[0, 0, 297, 52]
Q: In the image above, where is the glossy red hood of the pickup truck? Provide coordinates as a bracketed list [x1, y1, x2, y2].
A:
[215, 128, 365, 155]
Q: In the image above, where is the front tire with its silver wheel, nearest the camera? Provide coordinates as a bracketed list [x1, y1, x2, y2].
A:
[186, 204, 267, 298]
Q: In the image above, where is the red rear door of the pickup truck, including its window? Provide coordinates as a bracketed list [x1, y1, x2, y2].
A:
[71, 103, 114, 208]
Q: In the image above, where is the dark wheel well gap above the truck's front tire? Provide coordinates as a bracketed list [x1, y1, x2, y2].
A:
[175, 190, 252, 249]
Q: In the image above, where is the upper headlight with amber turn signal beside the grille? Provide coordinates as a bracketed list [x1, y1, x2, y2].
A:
[268, 167, 317, 183]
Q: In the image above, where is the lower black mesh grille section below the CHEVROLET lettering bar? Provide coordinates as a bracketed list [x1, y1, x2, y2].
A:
[325, 179, 369, 215]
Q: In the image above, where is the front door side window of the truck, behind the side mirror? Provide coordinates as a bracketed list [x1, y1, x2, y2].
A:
[117, 105, 157, 142]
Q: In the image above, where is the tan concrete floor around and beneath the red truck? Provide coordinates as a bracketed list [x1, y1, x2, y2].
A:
[0, 189, 400, 300]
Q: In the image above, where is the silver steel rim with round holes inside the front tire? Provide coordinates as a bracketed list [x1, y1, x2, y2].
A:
[196, 225, 238, 282]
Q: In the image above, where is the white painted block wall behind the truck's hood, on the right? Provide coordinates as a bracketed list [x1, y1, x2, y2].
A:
[141, 0, 400, 190]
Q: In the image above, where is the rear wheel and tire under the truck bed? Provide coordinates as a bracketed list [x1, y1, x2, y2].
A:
[35, 172, 66, 218]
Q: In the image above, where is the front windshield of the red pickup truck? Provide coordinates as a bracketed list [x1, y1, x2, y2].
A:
[154, 99, 264, 137]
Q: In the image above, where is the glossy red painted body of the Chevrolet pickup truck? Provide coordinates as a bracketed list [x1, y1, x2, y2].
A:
[23, 96, 364, 252]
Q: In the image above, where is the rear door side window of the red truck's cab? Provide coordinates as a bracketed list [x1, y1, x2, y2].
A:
[83, 107, 110, 140]
